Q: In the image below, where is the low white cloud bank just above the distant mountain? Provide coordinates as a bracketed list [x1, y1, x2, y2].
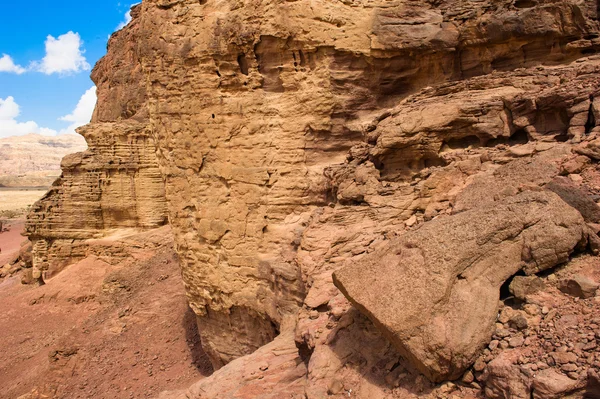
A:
[0, 86, 96, 138]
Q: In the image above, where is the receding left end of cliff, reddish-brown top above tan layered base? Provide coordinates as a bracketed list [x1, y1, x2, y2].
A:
[26, 9, 167, 279]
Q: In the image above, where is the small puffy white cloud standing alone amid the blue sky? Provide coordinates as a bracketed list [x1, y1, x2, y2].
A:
[30, 32, 91, 75]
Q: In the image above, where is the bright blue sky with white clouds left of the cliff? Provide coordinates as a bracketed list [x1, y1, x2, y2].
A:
[0, 0, 139, 138]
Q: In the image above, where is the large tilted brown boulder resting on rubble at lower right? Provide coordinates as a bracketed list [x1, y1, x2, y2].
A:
[334, 191, 589, 382]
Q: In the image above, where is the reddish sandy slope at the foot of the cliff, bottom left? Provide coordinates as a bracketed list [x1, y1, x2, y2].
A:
[0, 228, 211, 399]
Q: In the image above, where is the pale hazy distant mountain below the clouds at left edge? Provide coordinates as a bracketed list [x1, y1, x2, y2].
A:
[0, 134, 87, 187]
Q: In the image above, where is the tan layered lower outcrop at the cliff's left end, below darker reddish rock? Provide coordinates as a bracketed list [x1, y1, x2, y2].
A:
[26, 123, 167, 278]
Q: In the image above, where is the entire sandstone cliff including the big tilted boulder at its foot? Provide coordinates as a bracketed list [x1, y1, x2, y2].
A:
[28, 0, 600, 399]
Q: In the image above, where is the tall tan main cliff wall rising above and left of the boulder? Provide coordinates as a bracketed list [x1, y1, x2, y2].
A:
[134, 1, 597, 365]
